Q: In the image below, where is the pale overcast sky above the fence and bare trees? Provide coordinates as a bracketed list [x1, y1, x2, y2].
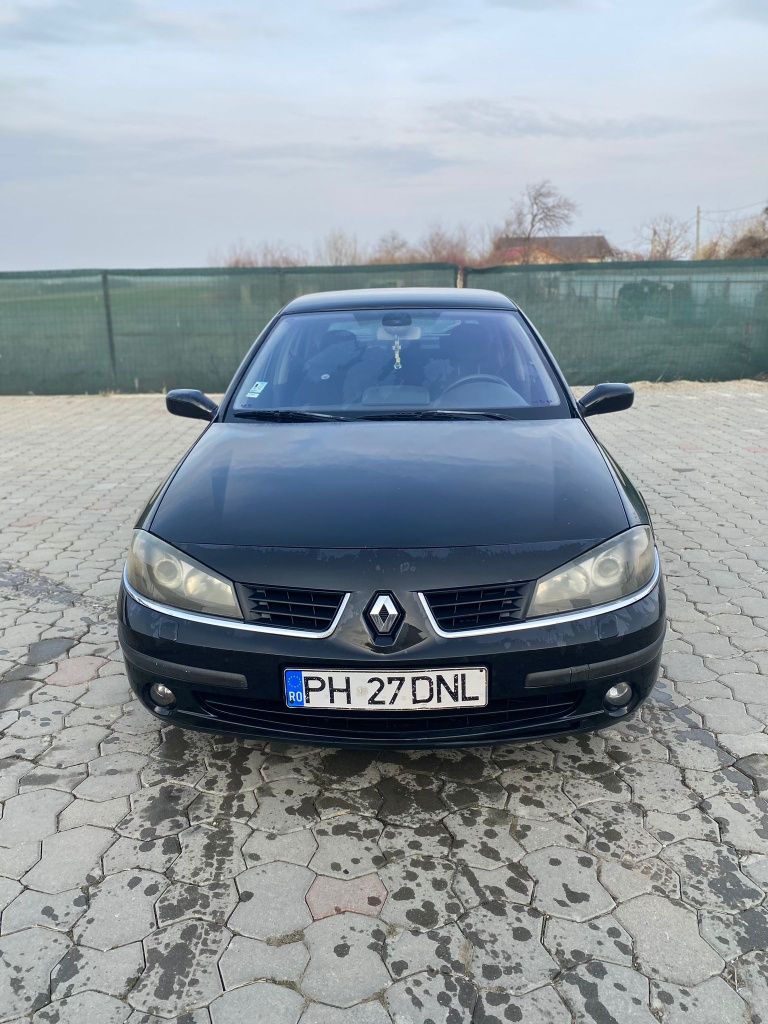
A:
[0, 0, 768, 270]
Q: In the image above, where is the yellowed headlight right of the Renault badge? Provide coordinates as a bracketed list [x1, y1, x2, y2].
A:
[528, 526, 655, 618]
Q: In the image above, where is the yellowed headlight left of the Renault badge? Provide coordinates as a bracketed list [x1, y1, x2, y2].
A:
[125, 529, 243, 618]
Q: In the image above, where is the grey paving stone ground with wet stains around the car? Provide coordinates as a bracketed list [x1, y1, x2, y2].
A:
[0, 381, 768, 1024]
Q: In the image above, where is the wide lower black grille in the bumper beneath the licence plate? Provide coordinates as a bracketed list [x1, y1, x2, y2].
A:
[197, 690, 584, 746]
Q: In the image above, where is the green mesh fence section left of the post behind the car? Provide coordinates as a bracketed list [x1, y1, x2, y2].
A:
[0, 263, 458, 394]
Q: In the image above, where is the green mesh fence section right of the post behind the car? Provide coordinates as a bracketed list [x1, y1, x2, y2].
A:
[464, 260, 768, 384]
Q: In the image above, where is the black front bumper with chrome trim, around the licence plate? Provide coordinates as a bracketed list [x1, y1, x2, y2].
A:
[118, 575, 666, 749]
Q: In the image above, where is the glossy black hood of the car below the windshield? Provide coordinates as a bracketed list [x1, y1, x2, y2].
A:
[150, 419, 628, 564]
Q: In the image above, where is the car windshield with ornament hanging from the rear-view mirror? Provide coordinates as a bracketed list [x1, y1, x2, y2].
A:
[229, 308, 570, 420]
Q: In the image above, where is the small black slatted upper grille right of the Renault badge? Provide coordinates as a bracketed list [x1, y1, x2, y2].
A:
[424, 582, 534, 633]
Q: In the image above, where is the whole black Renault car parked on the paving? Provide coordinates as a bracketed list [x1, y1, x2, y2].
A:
[119, 289, 665, 748]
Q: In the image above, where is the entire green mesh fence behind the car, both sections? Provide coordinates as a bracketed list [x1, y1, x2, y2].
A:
[0, 260, 768, 394]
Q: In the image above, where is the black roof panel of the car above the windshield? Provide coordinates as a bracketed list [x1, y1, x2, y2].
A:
[283, 288, 517, 313]
